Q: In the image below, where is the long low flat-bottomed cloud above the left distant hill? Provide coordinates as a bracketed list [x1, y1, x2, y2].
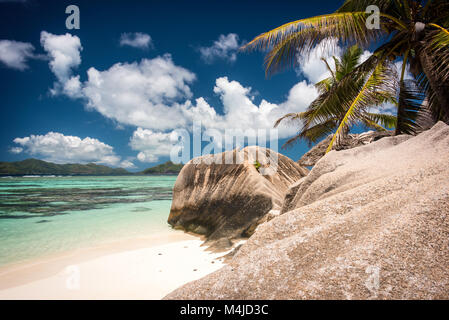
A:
[11, 132, 132, 167]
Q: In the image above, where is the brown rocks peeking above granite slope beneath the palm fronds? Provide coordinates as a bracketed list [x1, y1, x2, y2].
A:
[298, 131, 393, 167]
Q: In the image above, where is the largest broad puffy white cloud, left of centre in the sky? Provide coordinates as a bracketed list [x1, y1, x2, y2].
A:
[83, 54, 195, 130]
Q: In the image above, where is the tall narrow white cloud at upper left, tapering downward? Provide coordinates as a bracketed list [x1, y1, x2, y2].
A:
[41, 31, 83, 97]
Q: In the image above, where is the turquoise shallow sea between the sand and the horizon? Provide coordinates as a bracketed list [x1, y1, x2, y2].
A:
[0, 176, 176, 266]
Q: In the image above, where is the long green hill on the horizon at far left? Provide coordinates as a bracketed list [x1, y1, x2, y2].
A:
[0, 159, 130, 175]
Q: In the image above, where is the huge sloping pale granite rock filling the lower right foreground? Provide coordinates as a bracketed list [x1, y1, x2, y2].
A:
[166, 122, 449, 299]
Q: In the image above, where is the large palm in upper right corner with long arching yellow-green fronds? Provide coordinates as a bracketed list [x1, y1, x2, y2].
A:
[243, 0, 449, 150]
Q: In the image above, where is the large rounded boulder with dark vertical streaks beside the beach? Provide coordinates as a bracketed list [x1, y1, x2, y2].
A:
[168, 147, 308, 240]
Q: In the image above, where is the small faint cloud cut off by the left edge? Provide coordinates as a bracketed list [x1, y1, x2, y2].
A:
[0, 40, 36, 70]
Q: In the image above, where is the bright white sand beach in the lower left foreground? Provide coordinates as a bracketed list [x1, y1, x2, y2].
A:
[0, 233, 226, 299]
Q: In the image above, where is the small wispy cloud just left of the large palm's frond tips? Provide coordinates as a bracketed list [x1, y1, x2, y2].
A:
[199, 33, 241, 63]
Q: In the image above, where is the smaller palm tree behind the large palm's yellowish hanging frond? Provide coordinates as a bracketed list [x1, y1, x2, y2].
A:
[275, 45, 396, 148]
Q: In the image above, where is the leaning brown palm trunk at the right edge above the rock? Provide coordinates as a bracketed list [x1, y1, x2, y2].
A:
[419, 50, 449, 122]
